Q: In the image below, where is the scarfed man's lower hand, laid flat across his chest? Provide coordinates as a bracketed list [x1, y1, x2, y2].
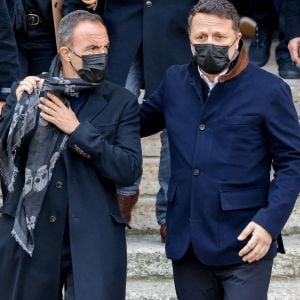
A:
[39, 93, 79, 134]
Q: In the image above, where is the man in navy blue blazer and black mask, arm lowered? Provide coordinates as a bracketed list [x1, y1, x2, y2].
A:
[141, 0, 300, 300]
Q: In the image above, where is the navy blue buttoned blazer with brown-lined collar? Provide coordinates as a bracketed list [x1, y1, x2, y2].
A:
[141, 48, 300, 265]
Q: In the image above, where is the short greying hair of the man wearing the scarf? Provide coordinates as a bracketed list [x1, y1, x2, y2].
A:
[57, 10, 104, 48]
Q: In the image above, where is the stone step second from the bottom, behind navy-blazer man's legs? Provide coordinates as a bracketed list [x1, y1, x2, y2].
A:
[127, 235, 300, 278]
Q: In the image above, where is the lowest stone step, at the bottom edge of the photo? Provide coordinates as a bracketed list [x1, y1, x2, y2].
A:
[126, 277, 300, 300]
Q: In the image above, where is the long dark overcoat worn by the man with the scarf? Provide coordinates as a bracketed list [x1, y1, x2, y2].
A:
[0, 81, 141, 300]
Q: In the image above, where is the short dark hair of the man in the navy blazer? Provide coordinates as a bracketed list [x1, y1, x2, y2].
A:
[188, 0, 240, 33]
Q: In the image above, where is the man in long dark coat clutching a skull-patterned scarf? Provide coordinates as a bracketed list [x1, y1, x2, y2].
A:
[0, 10, 142, 300]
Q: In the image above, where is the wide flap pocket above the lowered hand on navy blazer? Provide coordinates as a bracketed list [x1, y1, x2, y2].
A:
[220, 188, 268, 211]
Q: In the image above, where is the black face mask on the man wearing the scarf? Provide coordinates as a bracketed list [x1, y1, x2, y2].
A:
[71, 50, 108, 83]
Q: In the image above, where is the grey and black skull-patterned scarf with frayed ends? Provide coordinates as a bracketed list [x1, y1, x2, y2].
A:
[0, 56, 96, 256]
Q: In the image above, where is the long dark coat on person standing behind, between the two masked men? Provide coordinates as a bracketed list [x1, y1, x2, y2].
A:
[64, 0, 197, 96]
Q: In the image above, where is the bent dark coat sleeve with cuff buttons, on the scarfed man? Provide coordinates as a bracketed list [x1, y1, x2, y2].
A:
[68, 99, 142, 186]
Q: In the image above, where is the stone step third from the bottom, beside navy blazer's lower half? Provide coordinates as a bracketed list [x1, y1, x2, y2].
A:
[129, 196, 300, 235]
